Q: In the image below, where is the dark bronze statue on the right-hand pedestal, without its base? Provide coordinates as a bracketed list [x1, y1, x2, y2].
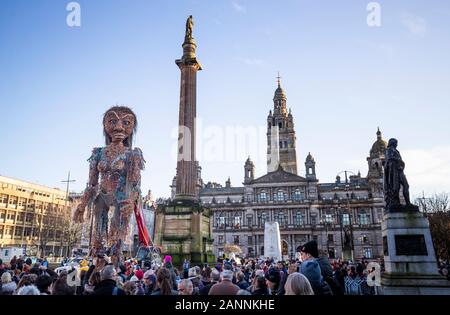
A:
[384, 138, 418, 212]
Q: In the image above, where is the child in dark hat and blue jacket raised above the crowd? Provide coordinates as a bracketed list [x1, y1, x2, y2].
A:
[300, 240, 333, 295]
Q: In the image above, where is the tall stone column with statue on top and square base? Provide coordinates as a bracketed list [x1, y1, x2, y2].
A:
[155, 15, 215, 266]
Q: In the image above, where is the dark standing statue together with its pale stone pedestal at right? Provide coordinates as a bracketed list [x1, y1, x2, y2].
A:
[381, 139, 450, 295]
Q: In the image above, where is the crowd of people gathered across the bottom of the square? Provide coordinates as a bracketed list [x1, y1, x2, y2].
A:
[0, 241, 400, 296]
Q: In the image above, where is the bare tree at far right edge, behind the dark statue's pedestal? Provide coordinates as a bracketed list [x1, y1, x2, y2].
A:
[416, 193, 450, 260]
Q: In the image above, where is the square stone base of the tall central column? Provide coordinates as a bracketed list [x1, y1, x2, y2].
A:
[155, 200, 215, 267]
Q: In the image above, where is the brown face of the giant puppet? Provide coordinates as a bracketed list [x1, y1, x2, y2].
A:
[103, 110, 136, 143]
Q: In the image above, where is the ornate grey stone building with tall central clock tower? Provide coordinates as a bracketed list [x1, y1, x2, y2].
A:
[199, 82, 386, 259]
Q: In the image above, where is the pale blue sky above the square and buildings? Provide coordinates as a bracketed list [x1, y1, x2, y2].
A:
[0, 0, 450, 197]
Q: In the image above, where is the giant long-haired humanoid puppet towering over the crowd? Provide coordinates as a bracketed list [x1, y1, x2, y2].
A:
[74, 106, 145, 265]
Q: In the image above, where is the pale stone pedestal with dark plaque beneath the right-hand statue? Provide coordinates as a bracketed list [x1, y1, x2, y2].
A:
[381, 209, 450, 295]
